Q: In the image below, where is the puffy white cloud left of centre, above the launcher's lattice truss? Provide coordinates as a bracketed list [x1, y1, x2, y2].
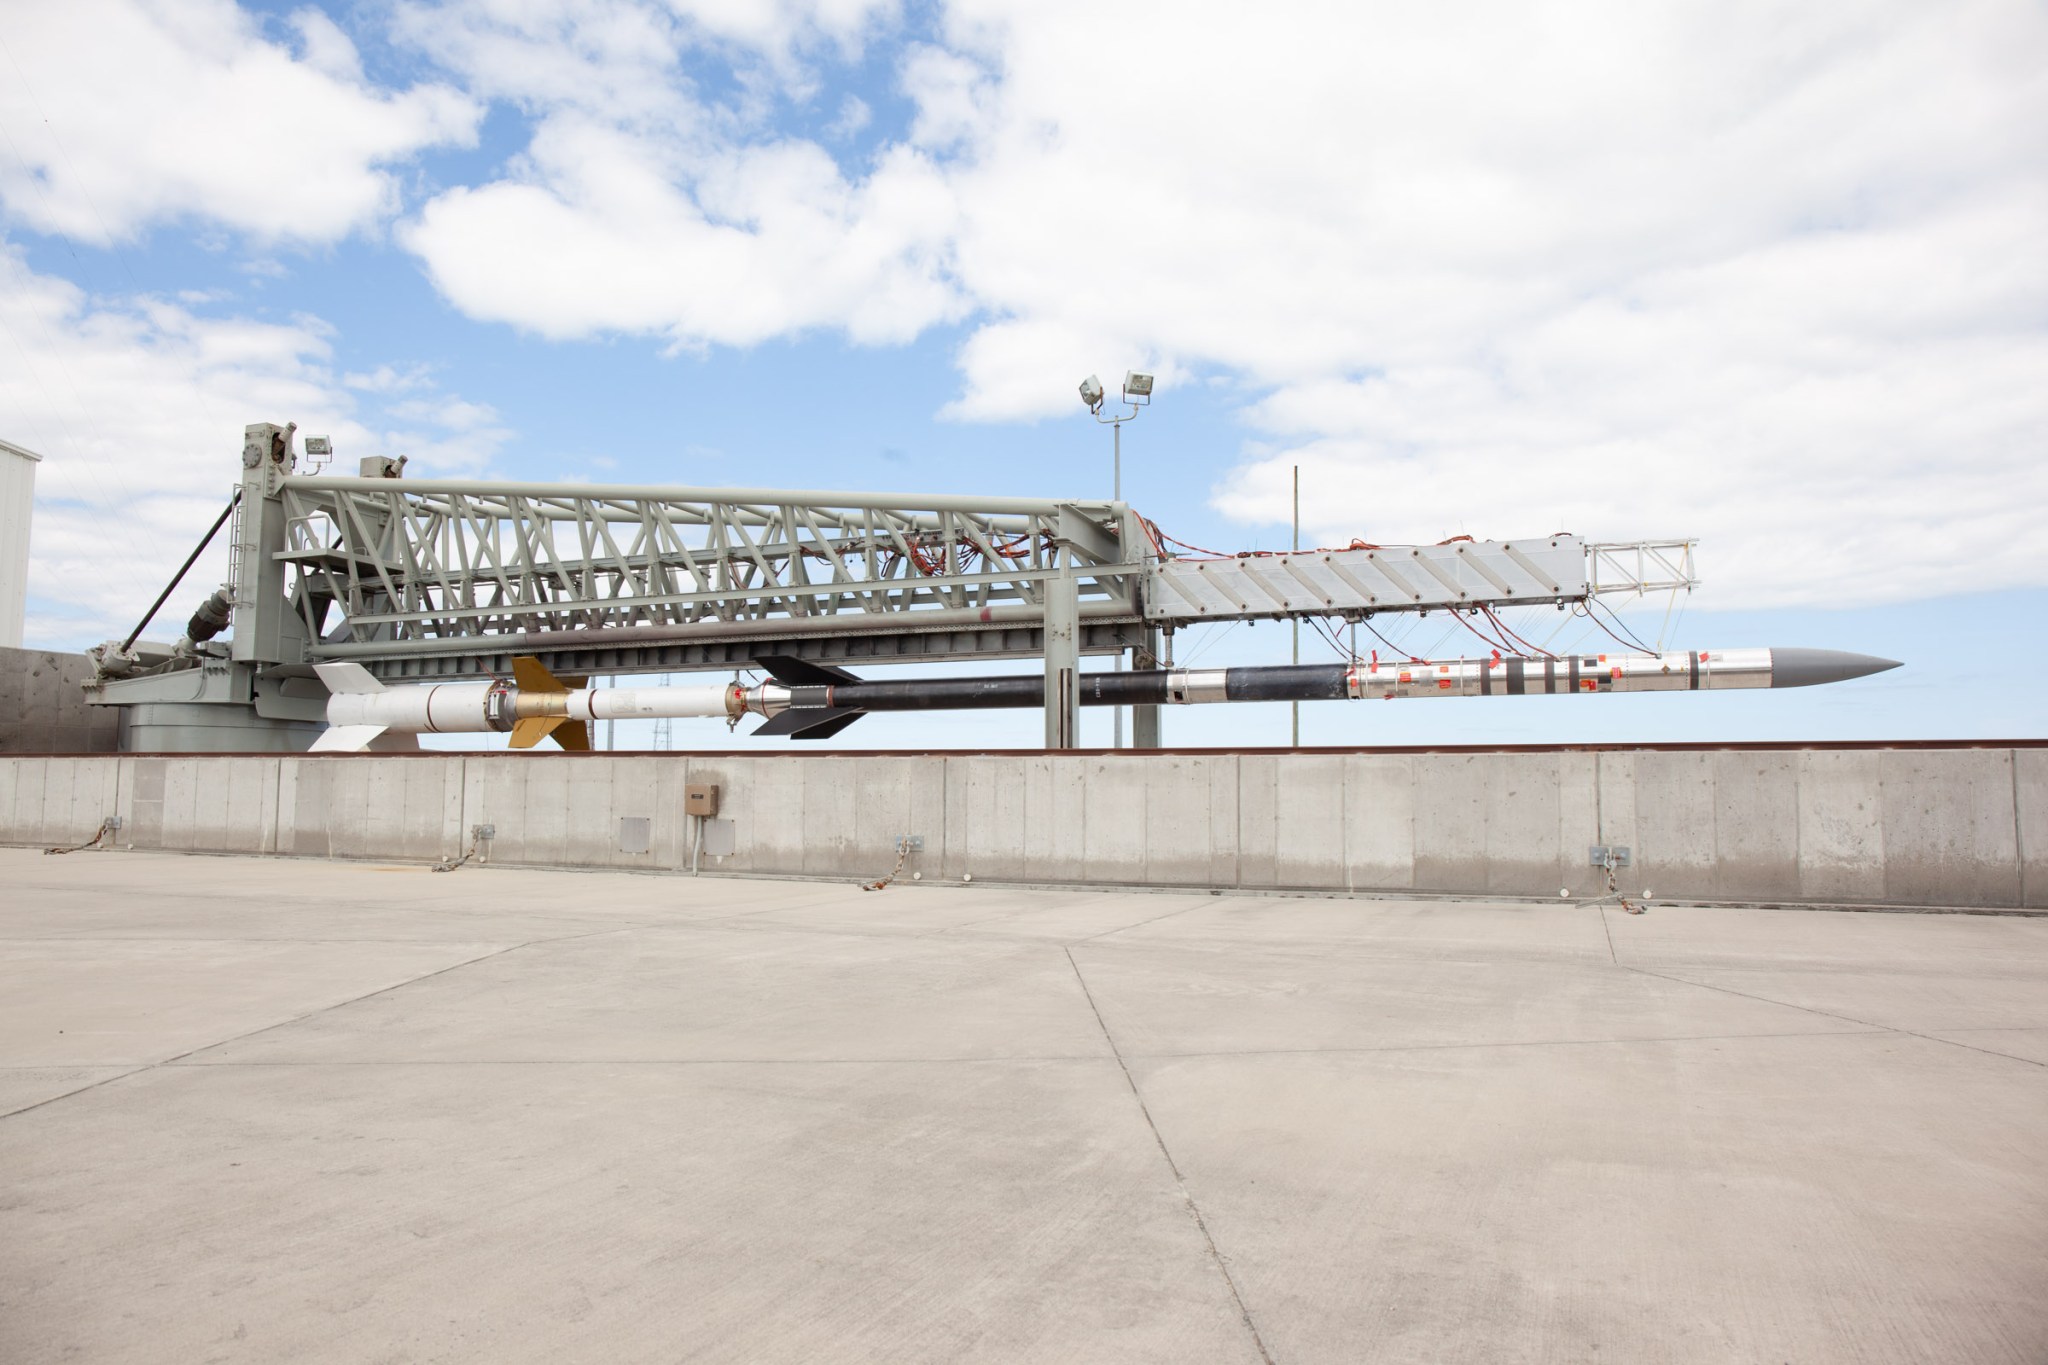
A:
[403, 115, 958, 346]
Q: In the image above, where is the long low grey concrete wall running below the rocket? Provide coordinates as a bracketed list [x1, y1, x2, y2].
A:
[0, 743, 2048, 907]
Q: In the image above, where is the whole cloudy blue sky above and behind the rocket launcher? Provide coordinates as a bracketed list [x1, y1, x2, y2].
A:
[0, 0, 2048, 745]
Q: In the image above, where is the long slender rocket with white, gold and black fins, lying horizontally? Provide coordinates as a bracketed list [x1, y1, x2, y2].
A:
[313, 649, 1898, 751]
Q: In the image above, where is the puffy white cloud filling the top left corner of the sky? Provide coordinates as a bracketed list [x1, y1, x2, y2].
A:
[0, 0, 479, 244]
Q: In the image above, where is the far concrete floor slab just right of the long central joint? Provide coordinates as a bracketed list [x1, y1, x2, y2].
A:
[1073, 939, 1864, 1056]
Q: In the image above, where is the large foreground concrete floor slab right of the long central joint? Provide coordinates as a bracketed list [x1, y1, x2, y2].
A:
[1133, 1033, 2048, 1365]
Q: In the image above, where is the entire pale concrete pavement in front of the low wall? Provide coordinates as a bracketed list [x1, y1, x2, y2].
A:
[0, 847, 2048, 1365]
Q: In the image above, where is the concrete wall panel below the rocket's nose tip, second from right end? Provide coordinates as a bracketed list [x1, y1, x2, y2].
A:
[1878, 749, 2019, 905]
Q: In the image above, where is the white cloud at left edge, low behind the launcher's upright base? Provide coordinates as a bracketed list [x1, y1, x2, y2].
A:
[0, 239, 506, 647]
